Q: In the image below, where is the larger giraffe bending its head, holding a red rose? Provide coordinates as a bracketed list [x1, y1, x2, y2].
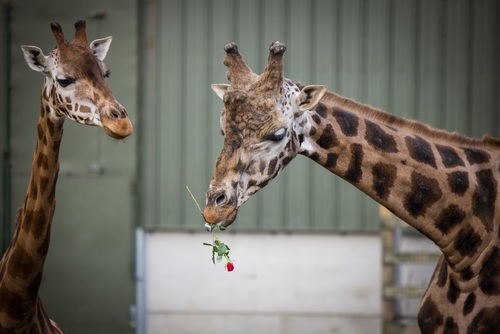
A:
[204, 42, 500, 334]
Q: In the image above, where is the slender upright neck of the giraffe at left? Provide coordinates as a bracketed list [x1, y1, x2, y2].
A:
[0, 89, 64, 328]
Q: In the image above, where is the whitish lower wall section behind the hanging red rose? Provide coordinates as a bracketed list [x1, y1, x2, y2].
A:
[146, 232, 382, 334]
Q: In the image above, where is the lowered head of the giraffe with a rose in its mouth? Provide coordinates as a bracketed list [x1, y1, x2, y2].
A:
[203, 42, 326, 230]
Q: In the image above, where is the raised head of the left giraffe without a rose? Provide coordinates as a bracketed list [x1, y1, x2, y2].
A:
[21, 20, 133, 139]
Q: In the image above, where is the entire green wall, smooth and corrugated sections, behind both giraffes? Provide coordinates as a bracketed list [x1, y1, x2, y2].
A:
[0, 0, 500, 333]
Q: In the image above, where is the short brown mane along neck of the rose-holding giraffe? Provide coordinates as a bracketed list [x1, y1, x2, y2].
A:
[296, 83, 500, 151]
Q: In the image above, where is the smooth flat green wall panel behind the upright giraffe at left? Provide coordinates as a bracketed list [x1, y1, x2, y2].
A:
[0, 0, 138, 334]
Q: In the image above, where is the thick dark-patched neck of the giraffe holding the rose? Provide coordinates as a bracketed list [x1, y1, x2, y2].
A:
[298, 93, 500, 271]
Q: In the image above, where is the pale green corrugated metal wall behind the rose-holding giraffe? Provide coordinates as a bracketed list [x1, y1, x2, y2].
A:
[139, 0, 500, 232]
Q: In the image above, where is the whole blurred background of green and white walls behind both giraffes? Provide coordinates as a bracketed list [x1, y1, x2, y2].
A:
[0, 0, 500, 334]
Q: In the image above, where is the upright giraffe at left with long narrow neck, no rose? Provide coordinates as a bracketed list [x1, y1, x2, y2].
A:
[0, 21, 132, 334]
